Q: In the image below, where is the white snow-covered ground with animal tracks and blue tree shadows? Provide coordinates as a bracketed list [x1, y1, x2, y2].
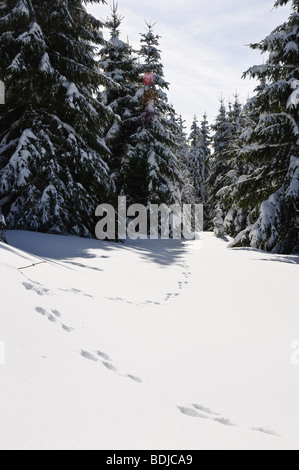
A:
[0, 232, 299, 450]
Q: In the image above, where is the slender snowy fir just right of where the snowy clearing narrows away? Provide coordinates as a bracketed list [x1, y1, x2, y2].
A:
[207, 99, 232, 237]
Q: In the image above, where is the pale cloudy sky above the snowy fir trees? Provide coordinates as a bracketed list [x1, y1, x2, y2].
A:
[88, 0, 290, 129]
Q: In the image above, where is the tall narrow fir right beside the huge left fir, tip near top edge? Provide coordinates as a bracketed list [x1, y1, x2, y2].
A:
[100, 2, 143, 195]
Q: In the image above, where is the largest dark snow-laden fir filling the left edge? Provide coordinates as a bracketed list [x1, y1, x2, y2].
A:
[0, 0, 113, 236]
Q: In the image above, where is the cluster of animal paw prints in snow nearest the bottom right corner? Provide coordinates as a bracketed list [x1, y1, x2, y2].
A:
[177, 403, 281, 437]
